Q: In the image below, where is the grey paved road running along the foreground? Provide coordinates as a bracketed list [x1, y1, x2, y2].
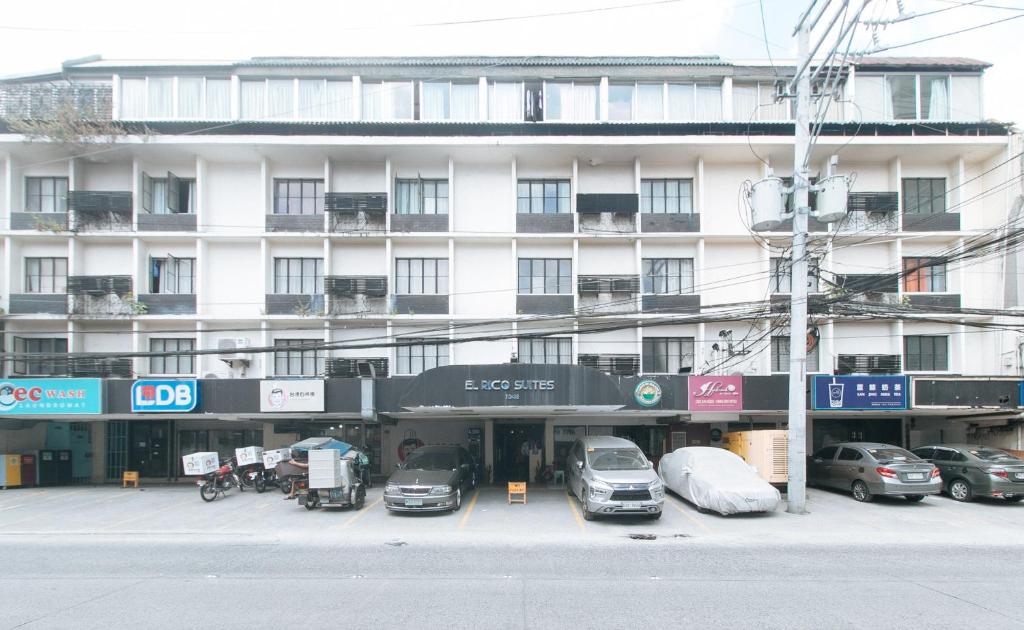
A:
[0, 535, 1024, 630]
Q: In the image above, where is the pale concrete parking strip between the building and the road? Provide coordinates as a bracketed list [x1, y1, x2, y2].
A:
[0, 485, 1024, 545]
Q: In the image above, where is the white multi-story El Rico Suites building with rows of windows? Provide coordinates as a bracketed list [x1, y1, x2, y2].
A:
[0, 56, 1022, 479]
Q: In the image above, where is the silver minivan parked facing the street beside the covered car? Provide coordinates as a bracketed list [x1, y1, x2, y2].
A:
[565, 435, 665, 520]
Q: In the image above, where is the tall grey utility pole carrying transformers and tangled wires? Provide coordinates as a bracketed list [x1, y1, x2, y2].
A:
[786, 16, 813, 514]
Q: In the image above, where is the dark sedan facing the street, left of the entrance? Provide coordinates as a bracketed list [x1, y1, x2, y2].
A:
[384, 446, 476, 512]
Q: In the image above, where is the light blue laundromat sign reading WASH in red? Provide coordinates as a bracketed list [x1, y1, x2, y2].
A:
[0, 378, 103, 416]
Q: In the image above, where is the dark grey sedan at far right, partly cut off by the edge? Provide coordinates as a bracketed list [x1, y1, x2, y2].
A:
[913, 444, 1024, 503]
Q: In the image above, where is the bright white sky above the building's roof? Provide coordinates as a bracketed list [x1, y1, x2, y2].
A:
[0, 0, 1024, 123]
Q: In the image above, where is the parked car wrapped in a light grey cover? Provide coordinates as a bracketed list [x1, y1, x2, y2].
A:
[657, 447, 782, 514]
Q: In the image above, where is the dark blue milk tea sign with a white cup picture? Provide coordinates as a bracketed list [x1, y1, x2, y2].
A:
[811, 374, 909, 411]
